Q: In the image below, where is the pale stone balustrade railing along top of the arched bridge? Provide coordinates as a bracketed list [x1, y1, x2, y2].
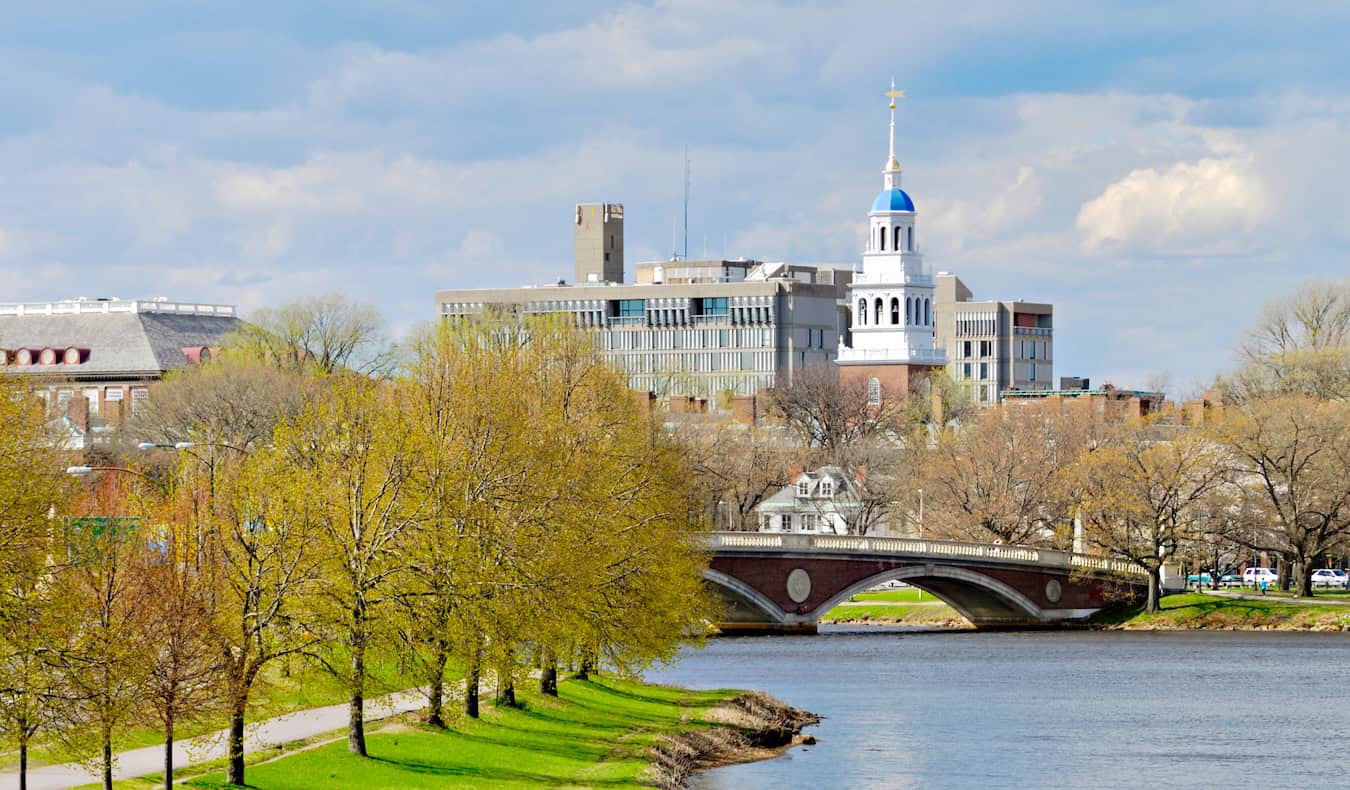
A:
[706, 532, 1145, 575]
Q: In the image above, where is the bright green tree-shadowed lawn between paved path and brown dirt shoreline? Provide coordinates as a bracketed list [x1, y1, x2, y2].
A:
[175, 677, 737, 790]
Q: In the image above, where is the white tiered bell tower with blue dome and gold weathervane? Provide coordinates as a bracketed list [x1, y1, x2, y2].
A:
[838, 82, 946, 401]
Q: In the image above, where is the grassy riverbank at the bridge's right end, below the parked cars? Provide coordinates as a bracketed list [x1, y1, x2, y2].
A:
[1094, 593, 1350, 632]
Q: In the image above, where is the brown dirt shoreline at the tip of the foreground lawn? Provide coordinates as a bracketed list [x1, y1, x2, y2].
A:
[649, 691, 821, 790]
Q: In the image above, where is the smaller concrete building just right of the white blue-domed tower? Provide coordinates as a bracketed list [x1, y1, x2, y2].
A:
[936, 271, 1054, 405]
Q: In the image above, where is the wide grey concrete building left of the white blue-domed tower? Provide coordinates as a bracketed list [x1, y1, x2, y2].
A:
[436, 245, 852, 400]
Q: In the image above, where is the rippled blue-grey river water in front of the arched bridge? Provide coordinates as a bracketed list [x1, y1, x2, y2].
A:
[647, 627, 1350, 790]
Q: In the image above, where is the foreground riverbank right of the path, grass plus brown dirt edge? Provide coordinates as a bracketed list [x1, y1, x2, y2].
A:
[151, 677, 817, 790]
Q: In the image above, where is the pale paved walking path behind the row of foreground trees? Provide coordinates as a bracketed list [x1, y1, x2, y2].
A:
[0, 691, 427, 790]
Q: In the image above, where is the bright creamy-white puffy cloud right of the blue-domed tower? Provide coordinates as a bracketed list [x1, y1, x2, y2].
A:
[1075, 157, 1270, 254]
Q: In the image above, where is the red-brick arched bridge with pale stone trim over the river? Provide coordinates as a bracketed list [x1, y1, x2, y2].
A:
[705, 532, 1148, 632]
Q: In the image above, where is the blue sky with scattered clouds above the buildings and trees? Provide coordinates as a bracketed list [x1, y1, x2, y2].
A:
[0, 0, 1350, 393]
